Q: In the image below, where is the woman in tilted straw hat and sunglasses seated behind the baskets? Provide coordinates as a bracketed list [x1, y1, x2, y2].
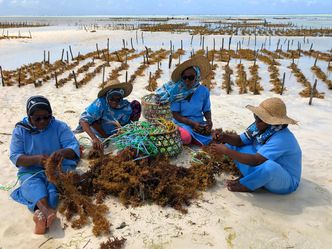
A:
[156, 55, 212, 145]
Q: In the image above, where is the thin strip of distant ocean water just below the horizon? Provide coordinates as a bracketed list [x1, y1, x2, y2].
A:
[0, 14, 332, 28]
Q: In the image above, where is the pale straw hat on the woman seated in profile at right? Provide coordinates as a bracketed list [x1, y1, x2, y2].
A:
[246, 98, 297, 125]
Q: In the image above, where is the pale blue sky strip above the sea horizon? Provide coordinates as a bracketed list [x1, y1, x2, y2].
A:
[0, 0, 332, 16]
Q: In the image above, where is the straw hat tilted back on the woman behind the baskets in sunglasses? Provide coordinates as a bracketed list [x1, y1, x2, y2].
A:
[172, 55, 211, 82]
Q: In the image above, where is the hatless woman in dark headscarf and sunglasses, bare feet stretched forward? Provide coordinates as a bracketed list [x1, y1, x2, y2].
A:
[10, 96, 80, 234]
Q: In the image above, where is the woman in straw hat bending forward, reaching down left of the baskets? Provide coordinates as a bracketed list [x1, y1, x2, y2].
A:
[74, 80, 141, 150]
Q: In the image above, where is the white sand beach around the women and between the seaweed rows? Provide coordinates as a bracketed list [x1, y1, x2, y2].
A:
[0, 28, 332, 249]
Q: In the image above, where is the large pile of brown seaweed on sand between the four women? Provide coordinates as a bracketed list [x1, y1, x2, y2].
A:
[46, 140, 237, 236]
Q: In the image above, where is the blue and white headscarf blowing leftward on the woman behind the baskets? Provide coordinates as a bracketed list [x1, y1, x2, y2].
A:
[156, 66, 201, 104]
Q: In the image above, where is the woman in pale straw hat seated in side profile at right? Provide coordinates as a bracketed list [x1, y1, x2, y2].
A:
[212, 98, 302, 194]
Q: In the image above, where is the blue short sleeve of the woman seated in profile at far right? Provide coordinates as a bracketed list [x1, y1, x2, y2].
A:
[257, 134, 289, 161]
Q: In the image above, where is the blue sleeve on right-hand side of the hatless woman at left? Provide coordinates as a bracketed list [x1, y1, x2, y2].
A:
[59, 122, 80, 158]
